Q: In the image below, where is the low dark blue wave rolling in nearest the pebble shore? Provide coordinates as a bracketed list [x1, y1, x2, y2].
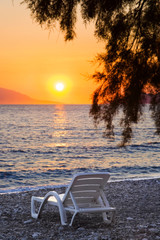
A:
[0, 166, 160, 193]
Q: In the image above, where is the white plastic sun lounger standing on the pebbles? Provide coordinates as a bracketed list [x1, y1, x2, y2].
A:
[31, 173, 115, 226]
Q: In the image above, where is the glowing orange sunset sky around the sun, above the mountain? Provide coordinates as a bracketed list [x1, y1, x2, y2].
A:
[0, 0, 104, 104]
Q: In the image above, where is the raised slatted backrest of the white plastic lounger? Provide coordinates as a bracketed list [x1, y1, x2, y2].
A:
[63, 173, 109, 206]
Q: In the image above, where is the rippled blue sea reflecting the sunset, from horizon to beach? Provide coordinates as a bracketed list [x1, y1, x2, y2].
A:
[0, 105, 160, 192]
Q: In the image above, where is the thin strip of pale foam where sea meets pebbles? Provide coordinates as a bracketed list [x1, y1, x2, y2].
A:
[0, 176, 160, 196]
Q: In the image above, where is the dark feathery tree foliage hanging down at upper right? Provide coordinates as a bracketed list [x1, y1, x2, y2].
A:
[23, 0, 160, 145]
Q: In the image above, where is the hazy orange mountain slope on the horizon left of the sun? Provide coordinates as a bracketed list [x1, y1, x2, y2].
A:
[0, 88, 57, 104]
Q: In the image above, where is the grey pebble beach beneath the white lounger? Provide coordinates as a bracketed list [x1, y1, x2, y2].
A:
[0, 178, 160, 240]
